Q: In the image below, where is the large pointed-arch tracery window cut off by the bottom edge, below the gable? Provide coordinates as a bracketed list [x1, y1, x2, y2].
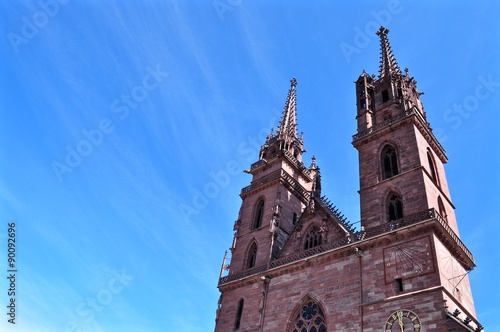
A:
[287, 295, 327, 332]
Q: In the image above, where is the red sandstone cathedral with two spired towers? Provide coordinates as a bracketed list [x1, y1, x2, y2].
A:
[215, 27, 483, 332]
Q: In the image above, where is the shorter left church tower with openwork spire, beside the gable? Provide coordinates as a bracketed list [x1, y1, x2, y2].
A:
[223, 79, 315, 282]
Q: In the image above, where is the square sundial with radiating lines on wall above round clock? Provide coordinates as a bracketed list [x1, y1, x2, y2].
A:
[384, 236, 434, 283]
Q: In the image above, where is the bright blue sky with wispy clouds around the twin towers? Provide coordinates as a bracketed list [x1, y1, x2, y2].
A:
[0, 0, 500, 332]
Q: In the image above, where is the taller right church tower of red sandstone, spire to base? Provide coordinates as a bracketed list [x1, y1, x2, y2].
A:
[353, 27, 482, 331]
